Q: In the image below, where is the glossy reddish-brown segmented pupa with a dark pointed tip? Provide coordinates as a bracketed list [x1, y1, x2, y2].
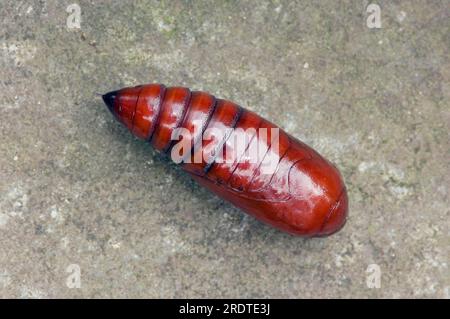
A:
[103, 84, 348, 236]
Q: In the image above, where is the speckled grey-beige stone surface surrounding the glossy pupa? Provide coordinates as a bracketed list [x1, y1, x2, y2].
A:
[0, 0, 450, 298]
